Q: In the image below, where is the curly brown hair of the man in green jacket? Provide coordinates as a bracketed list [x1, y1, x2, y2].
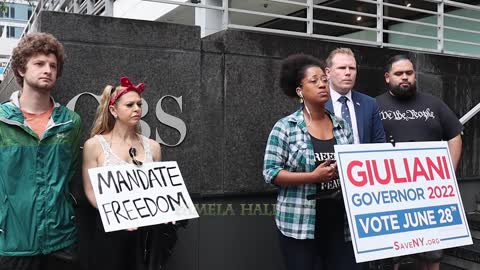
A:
[12, 33, 65, 87]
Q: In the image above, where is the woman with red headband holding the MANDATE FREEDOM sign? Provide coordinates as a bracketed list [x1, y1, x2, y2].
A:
[82, 77, 166, 270]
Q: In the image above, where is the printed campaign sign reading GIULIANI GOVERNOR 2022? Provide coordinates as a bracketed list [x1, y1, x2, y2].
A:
[335, 142, 472, 262]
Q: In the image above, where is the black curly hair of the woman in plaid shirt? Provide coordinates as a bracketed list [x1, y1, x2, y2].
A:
[280, 53, 324, 97]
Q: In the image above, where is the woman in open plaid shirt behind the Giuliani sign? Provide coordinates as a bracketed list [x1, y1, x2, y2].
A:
[263, 54, 360, 270]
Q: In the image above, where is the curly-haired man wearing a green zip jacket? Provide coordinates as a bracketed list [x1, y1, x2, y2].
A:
[0, 33, 80, 270]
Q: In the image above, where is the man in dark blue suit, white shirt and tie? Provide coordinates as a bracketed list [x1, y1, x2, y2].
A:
[325, 48, 385, 143]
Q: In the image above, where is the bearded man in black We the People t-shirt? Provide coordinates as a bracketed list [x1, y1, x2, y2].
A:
[377, 55, 463, 270]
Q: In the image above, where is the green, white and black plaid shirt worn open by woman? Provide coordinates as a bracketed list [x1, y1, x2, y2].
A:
[263, 108, 353, 240]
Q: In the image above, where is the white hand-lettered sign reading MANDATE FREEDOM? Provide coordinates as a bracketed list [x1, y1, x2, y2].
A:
[88, 161, 198, 232]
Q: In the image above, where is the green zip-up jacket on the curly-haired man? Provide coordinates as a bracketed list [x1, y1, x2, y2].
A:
[0, 92, 81, 256]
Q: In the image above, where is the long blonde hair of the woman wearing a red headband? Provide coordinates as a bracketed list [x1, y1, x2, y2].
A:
[90, 85, 141, 137]
